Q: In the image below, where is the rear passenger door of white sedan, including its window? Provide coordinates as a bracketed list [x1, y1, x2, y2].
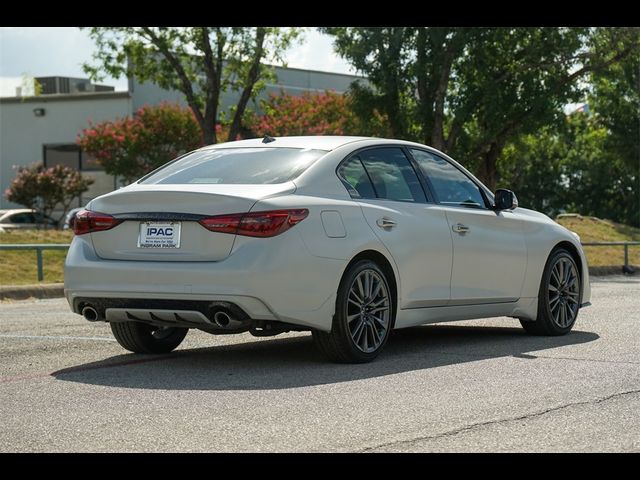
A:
[338, 147, 453, 309]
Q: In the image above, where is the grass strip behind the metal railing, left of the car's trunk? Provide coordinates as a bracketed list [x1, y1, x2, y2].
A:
[0, 230, 73, 285]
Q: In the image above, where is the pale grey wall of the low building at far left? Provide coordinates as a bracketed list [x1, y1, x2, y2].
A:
[0, 92, 131, 208]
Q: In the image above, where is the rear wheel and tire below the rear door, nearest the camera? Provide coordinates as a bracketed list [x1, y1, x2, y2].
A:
[313, 260, 395, 363]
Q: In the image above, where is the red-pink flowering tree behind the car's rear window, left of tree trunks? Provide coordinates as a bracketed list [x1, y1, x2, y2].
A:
[77, 103, 202, 183]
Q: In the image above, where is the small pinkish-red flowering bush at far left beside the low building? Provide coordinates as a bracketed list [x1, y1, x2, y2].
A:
[4, 164, 93, 225]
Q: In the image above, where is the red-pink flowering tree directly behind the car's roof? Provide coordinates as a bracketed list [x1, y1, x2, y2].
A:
[245, 91, 385, 137]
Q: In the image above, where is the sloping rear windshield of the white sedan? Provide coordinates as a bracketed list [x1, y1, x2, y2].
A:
[140, 147, 327, 184]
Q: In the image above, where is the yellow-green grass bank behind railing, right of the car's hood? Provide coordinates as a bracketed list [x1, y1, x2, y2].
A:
[556, 215, 640, 267]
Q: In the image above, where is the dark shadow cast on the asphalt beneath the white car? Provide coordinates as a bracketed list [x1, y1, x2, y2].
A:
[51, 325, 599, 390]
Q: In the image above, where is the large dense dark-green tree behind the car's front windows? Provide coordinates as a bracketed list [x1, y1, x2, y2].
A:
[322, 27, 640, 188]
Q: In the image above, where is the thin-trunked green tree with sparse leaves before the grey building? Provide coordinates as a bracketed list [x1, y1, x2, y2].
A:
[84, 27, 299, 144]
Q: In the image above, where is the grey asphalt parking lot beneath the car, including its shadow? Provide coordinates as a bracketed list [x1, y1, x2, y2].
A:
[0, 277, 640, 452]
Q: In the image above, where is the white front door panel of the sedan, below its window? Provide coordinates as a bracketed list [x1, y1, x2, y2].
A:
[443, 207, 527, 305]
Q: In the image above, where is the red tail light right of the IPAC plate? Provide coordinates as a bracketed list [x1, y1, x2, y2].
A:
[199, 208, 309, 237]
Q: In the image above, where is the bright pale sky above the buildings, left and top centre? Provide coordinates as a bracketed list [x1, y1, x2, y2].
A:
[0, 27, 355, 97]
